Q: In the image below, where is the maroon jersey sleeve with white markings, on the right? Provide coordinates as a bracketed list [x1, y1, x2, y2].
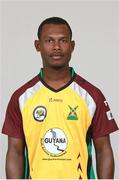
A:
[92, 91, 119, 138]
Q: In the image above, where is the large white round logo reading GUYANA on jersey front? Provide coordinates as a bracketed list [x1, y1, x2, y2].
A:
[41, 128, 68, 157]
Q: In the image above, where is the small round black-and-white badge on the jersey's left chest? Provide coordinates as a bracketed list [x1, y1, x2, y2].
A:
[33, 106, 47, 121]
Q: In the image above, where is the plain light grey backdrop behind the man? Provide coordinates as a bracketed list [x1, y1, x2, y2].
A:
[0, 0, 119, 178]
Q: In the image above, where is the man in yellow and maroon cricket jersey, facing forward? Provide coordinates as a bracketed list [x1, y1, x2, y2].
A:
[2, 17, 118, 179]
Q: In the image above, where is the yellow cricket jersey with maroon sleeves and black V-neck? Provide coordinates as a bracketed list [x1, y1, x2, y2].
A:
[2, 68, 118, 180]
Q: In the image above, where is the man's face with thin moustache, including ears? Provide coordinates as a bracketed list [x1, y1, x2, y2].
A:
[35, 24, 74, 68]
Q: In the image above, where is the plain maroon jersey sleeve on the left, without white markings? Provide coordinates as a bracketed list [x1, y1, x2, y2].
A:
[2, 93, 24, 139]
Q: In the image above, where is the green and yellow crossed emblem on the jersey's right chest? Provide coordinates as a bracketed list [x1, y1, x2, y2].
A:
[67, 105, 78, 120]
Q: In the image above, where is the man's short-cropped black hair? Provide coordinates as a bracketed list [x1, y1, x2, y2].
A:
[37, 17, 72, 39]
